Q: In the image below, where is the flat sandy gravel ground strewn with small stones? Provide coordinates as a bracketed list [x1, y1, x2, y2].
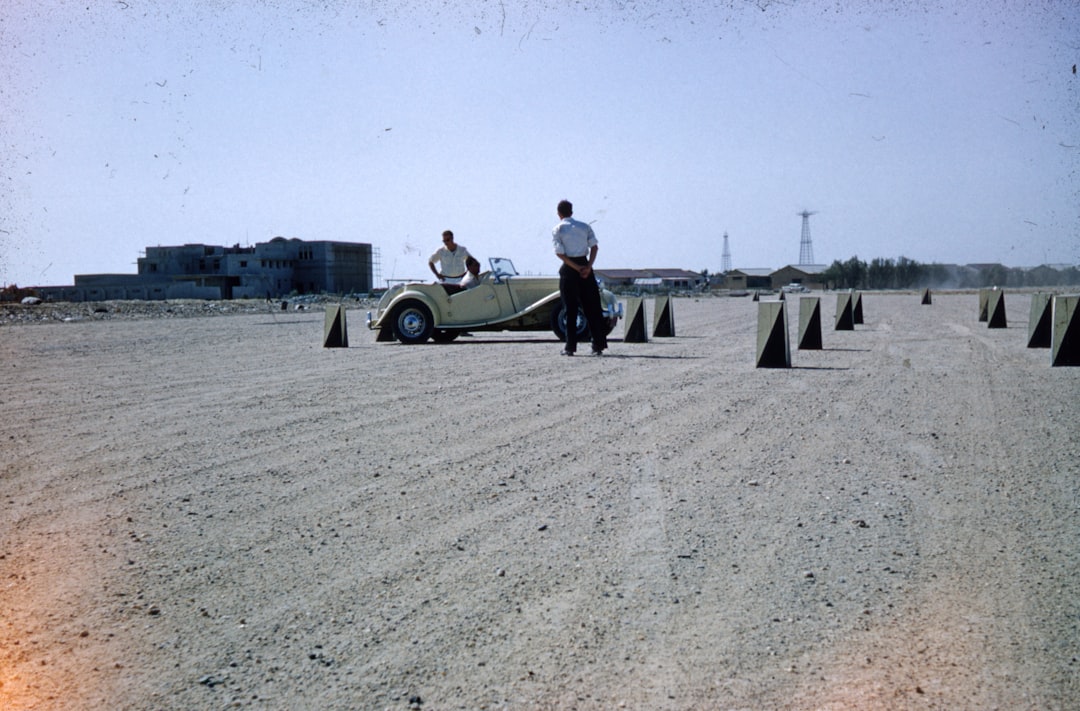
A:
[0, 293, 1080, 710]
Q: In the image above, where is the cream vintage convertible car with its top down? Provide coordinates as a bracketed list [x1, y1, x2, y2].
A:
[367, 257, 622, 344]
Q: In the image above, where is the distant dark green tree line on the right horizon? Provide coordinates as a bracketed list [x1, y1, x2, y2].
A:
[821, 256, 1080, 289]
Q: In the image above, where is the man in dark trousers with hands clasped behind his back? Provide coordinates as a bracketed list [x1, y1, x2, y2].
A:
[552, 200, 607, 356]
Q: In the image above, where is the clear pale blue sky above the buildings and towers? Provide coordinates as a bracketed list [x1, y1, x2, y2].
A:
[0, 0, 1080, 285]
